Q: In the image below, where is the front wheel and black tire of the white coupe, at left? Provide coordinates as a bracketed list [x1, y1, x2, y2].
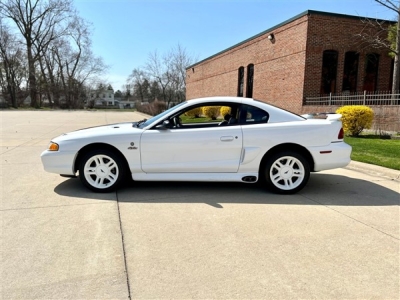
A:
[79, 149, 127, 193]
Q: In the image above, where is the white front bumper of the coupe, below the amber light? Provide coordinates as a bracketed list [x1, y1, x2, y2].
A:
[40, 150, 76, 175]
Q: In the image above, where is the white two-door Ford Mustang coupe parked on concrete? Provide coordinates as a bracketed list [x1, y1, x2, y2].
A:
[41, 97, 351, 194]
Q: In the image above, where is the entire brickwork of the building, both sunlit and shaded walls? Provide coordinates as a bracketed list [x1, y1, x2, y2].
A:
[186, 11, 391, 113]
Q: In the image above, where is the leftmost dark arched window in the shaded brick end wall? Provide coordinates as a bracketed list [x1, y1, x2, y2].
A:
[320, 50, 338, 95]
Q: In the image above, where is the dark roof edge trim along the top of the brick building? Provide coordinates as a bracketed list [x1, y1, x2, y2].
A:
[186, 9, 396, 70]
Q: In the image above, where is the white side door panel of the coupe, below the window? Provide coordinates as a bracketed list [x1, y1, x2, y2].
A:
[140, 105, 243, 173]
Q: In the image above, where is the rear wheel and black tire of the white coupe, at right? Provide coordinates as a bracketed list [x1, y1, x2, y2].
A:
[262, 151, 310, 194]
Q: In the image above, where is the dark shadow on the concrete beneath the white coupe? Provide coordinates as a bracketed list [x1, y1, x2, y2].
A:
[54, 173, 400, 208]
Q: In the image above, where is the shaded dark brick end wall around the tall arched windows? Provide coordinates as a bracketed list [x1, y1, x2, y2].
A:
[304, 14, 392, 97]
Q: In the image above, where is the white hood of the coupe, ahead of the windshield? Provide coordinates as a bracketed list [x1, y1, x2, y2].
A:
[53, 122, 143, 141]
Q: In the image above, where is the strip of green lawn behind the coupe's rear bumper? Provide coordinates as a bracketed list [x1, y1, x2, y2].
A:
[344, 135, 400, 170]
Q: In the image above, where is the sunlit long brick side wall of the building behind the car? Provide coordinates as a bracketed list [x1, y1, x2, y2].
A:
[186, 16, 307, 110]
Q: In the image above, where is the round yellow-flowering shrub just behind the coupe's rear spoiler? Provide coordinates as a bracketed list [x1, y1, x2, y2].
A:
[336, 105, 374, 136]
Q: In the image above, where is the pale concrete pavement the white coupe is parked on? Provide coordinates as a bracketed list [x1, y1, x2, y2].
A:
[0, 111, 400, 299]
